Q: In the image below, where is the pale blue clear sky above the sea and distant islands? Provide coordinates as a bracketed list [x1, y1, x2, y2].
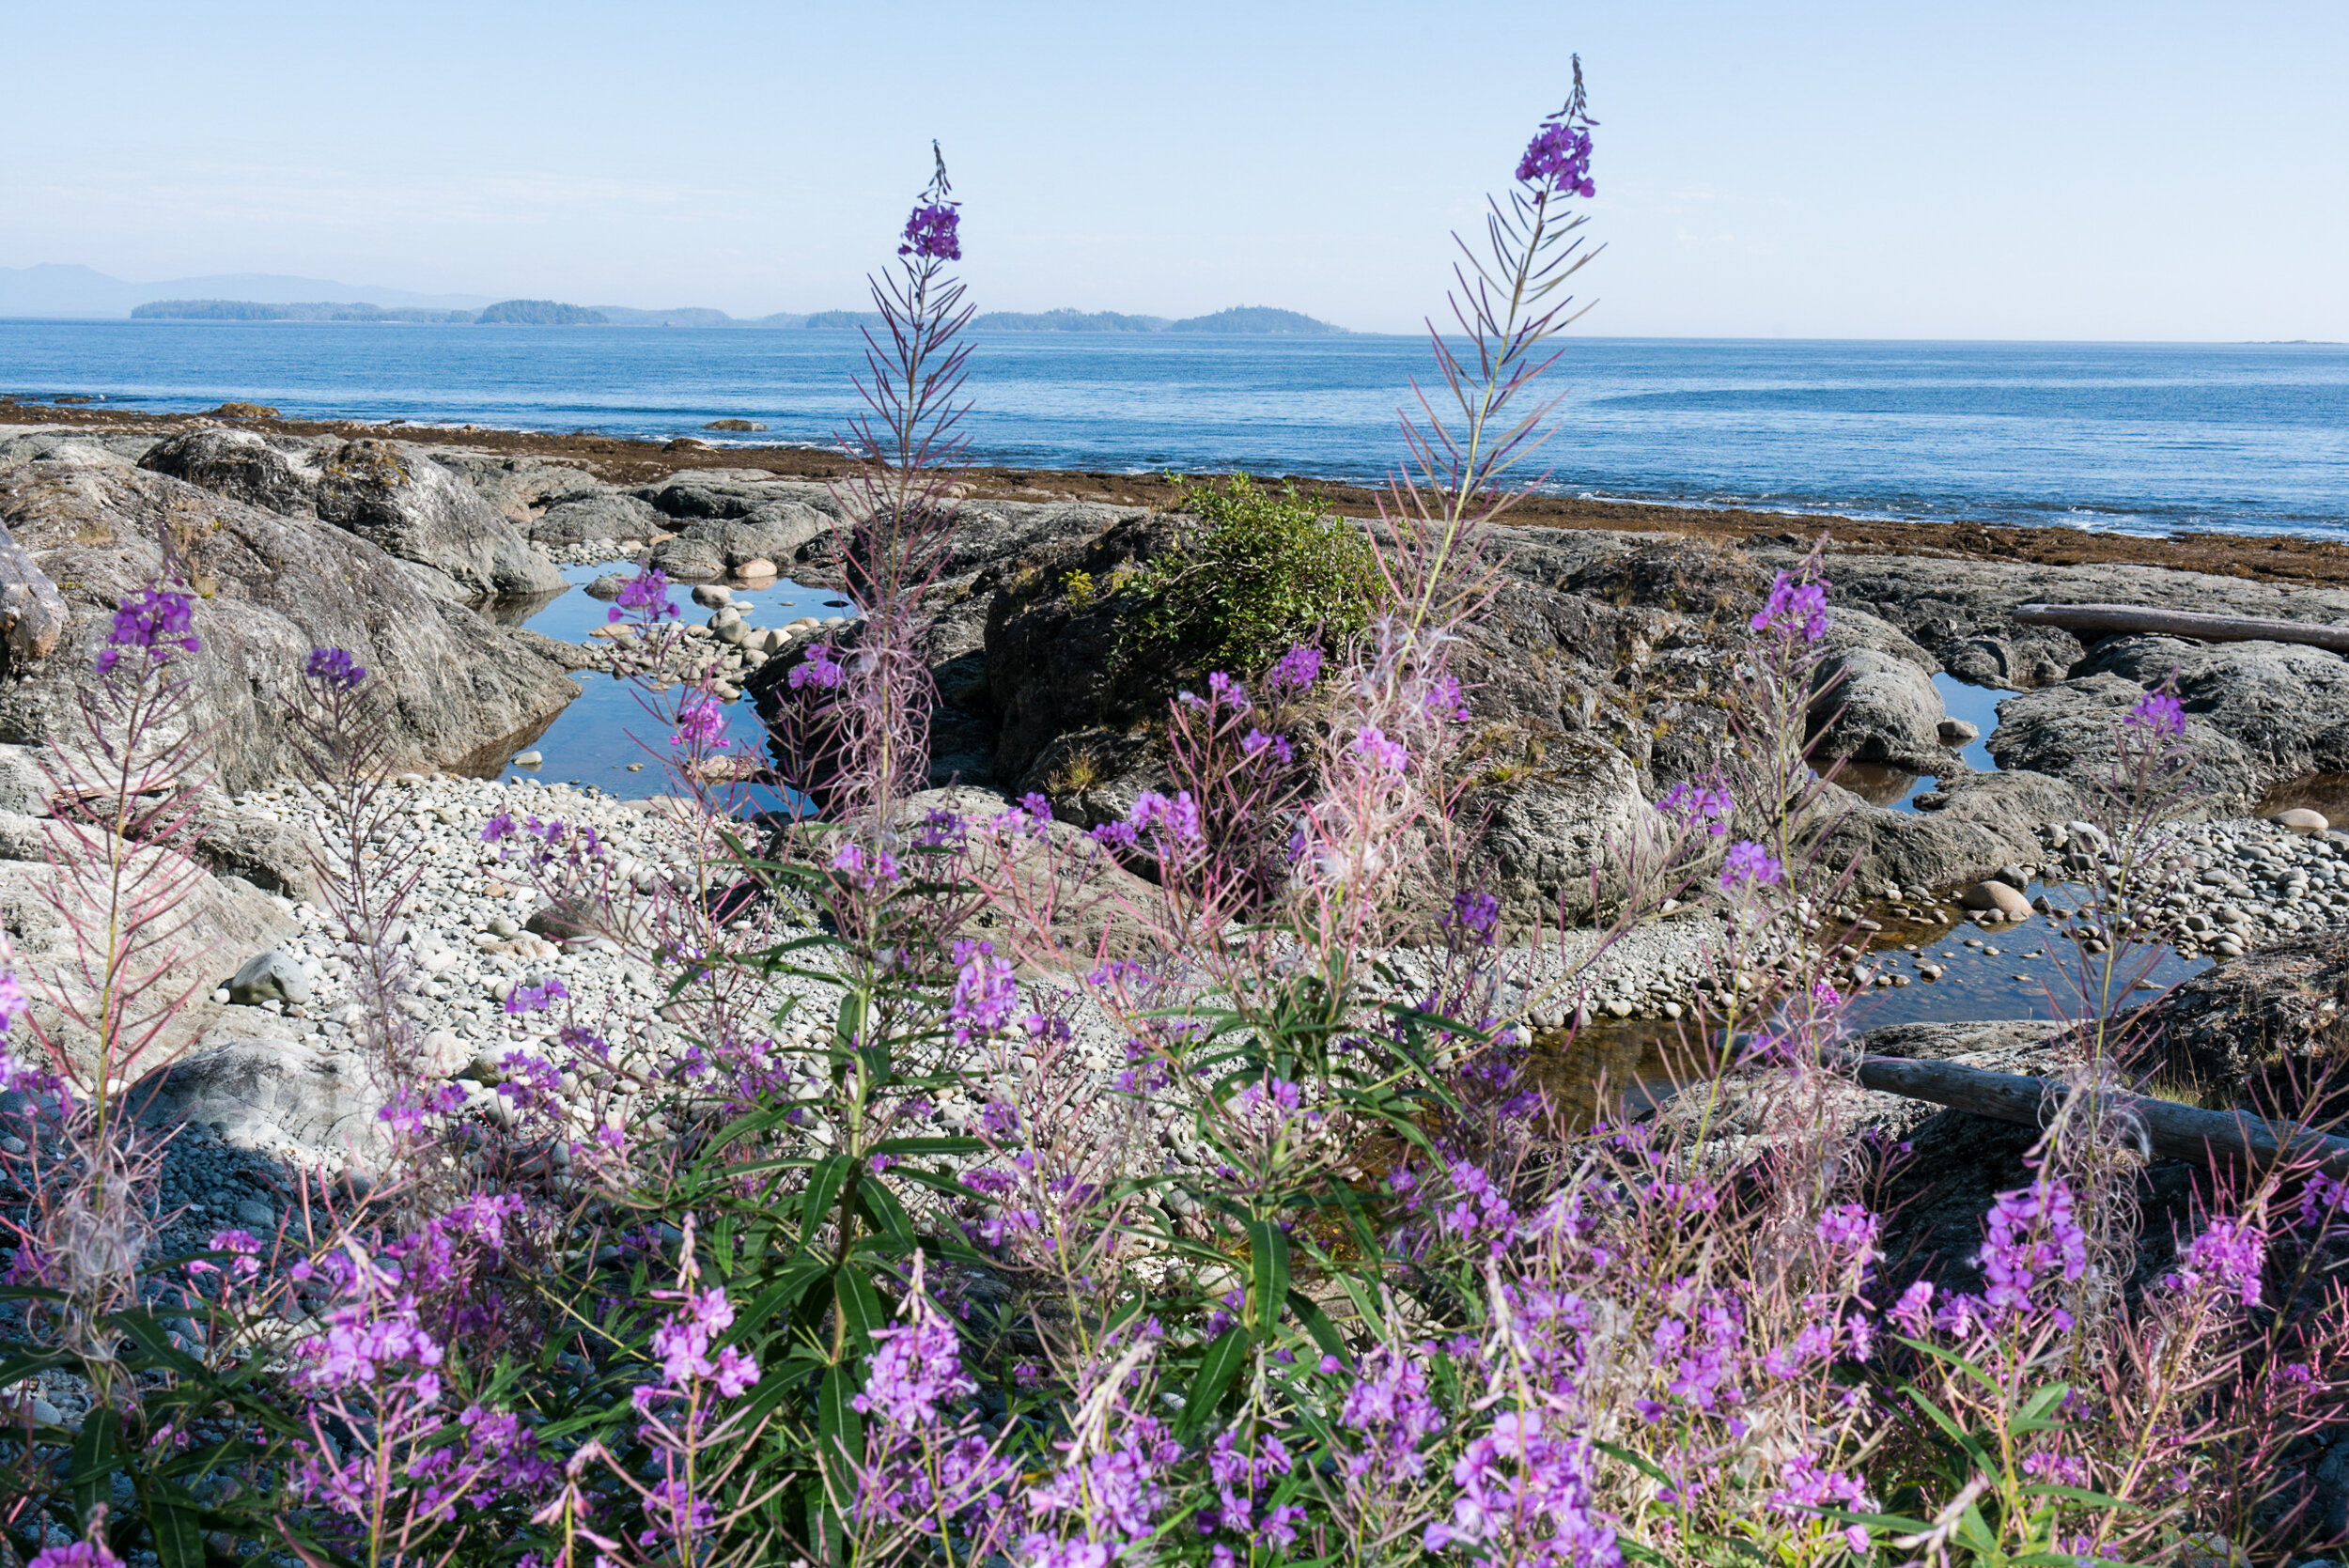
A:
[0, 0, 2349, 340]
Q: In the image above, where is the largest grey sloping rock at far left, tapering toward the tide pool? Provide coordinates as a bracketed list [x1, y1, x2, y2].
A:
[0, 460, 578, 791]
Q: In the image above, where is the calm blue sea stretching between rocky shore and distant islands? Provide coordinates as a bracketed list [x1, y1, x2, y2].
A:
[0, 321, 2349, 537]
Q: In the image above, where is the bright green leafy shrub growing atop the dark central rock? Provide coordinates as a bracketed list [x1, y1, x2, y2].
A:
[1118, 474, 1384, 676]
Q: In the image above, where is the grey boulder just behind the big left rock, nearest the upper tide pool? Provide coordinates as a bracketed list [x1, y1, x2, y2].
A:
[318, 442, 564, 594]
